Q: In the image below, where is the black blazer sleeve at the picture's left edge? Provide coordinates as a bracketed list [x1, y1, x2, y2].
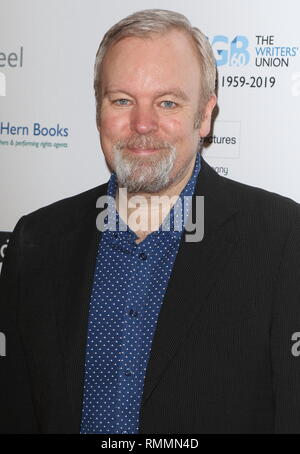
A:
[0, 216, 38, 434]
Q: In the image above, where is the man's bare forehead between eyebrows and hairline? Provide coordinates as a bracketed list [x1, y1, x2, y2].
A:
[102, 30, 201, 96]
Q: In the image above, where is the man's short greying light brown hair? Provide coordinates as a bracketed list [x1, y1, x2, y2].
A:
[94, 9, 217, 124]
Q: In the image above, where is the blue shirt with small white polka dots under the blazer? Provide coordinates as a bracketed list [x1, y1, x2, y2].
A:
[80, 152, 200, 434]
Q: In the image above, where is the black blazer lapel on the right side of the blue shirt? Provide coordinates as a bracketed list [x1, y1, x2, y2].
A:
[140, 159, 237, 412]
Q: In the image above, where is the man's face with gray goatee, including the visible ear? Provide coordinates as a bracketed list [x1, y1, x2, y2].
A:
[98, 30, 215, 193]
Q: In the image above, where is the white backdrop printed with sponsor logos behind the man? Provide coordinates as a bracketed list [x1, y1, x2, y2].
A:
[0, 0, 300, 241]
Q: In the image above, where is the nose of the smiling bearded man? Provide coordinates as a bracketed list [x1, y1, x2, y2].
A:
[131, 106, 158, 134]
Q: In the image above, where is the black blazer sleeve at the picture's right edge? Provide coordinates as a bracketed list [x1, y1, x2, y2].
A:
[271, 210, 300, 434]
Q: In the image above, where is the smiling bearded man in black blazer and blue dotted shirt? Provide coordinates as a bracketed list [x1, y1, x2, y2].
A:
[0, 10, 300, 434]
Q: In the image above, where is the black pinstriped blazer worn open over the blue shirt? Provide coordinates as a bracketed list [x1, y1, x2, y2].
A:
[0, 158, 300, 434]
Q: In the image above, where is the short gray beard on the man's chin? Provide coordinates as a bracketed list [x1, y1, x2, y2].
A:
[113, 143, 176, 193]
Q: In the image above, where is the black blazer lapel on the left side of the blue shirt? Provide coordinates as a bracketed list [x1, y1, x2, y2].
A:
[56, 184, 107, 433]
